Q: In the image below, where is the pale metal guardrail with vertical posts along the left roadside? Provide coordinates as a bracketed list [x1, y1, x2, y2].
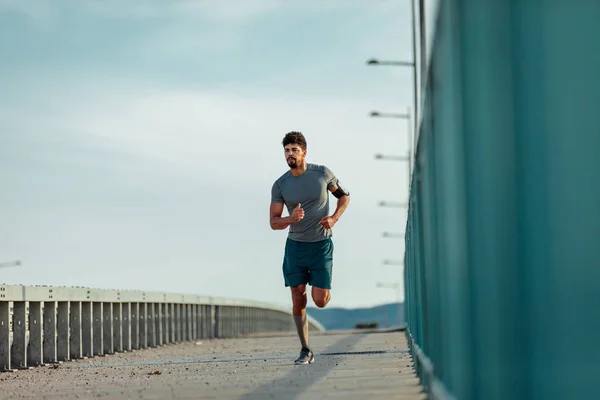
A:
[0, 285, 324, 371]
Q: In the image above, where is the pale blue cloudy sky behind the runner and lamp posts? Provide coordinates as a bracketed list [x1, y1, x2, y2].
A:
[0, 0, 426, 307]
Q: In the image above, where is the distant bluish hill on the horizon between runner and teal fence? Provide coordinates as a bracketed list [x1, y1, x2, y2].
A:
[306, 303, 405, 330]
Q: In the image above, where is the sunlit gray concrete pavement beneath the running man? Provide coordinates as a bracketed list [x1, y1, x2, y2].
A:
[0, 332, 426, 400]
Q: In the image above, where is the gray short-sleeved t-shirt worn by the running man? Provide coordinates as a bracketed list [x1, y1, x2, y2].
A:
[271, 163, 338, 242]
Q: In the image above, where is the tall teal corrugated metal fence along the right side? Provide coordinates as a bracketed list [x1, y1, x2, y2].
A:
[405, 0, 600, 400]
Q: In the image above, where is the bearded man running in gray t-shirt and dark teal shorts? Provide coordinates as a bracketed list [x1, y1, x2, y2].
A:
[270, 132, 350, 364]
